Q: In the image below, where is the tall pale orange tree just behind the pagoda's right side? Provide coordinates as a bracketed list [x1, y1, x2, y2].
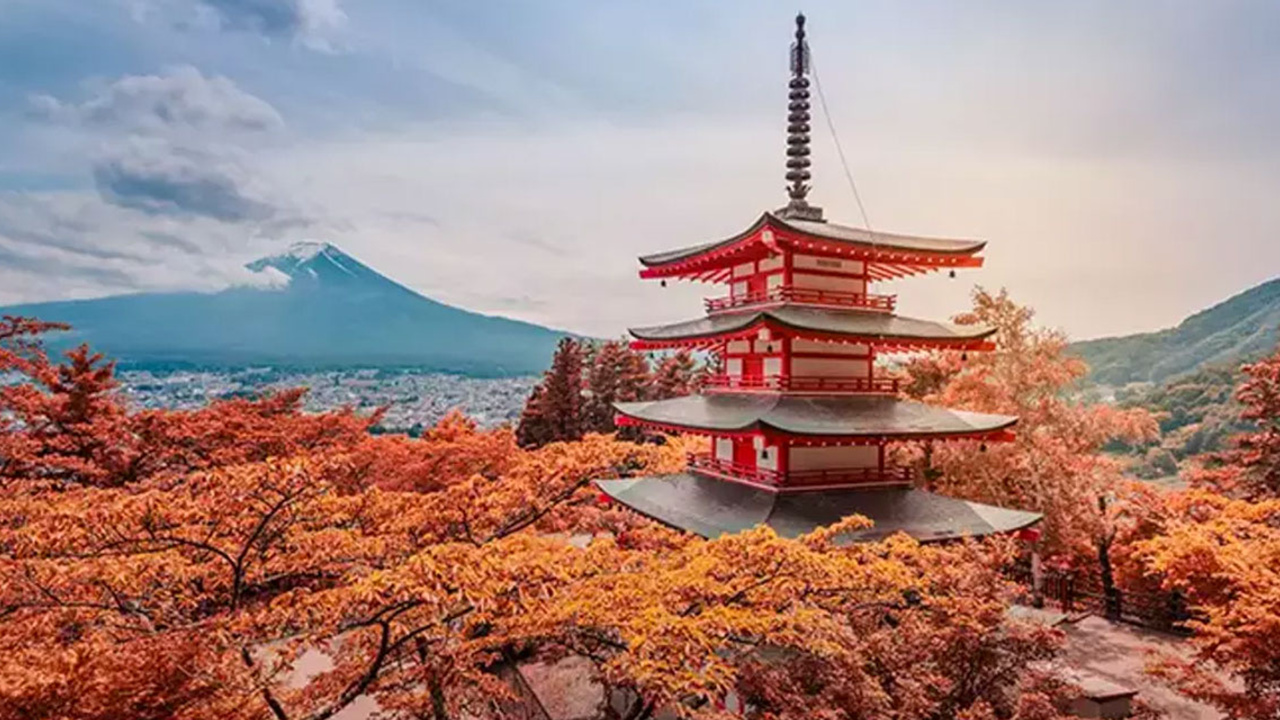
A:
[906, 288, 1158, 557]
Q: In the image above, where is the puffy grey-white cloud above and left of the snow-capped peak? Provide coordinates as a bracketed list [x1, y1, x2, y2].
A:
[31, 67, 284, 223]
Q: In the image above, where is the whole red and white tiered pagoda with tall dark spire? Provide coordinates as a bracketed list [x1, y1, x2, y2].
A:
[598, 15, 1041, 542]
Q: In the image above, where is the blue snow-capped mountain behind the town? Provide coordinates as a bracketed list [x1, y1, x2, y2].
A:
[0, 242, 564, 377]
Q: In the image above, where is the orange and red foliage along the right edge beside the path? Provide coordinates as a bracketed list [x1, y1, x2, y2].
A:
[1132, 352, 1280, 719]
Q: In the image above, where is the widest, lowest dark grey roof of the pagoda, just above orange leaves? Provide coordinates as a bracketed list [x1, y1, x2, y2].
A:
[595, 473, 1042, 542]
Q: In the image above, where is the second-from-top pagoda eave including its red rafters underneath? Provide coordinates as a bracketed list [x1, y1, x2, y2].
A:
[627, 306, 996, 351]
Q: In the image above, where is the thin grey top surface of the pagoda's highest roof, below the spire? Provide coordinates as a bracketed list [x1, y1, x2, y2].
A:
[640, 213, 987, 268]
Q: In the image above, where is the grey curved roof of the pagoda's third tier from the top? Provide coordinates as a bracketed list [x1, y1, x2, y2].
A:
[613, 393, 1018, 439]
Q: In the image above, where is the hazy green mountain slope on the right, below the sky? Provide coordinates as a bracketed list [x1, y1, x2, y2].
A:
[1071, 278, 1280, 386]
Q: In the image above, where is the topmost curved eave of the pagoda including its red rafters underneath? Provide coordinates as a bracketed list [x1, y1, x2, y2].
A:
[640, 213, 987, 279]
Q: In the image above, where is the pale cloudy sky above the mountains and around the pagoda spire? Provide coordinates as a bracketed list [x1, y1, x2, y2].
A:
[0, 0, 1280, 338]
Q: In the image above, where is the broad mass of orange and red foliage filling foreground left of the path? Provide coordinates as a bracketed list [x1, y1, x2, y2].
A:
[0, 317, 1062, 720]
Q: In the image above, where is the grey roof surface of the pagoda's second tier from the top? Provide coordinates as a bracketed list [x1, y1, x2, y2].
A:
[628, 304, 996, 346]
